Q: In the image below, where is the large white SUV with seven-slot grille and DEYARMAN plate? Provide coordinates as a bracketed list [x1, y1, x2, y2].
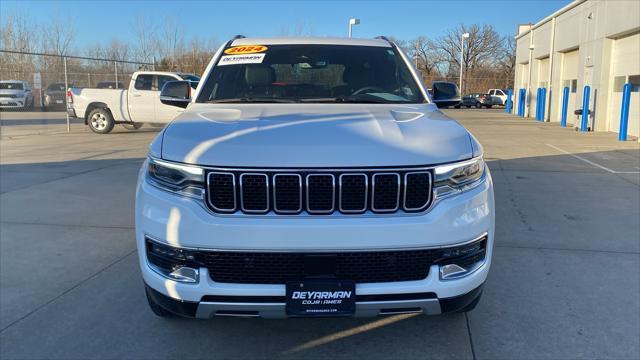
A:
[136, 37, 494, 318]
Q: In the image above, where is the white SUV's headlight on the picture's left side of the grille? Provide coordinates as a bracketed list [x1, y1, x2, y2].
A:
[147, 158, 204, 199]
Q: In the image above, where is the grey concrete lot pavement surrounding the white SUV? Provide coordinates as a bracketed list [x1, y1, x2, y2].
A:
[0, 109, 640, 359]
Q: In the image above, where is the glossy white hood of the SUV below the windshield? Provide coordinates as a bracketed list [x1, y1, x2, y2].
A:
[161, 104, 473, 167]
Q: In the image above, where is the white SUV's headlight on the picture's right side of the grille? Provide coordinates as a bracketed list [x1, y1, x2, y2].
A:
[434, 156, 485, 197]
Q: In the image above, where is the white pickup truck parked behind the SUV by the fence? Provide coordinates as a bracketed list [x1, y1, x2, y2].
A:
[67, 71, 200, 134]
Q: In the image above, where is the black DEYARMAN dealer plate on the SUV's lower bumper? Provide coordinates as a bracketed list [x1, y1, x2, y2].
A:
[286, 280, 356, 317]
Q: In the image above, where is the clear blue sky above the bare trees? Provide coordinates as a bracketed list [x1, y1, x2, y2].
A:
[0, 0, 570, 50]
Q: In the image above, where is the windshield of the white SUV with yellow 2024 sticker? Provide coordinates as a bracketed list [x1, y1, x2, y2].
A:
[197, 45, 425, 103]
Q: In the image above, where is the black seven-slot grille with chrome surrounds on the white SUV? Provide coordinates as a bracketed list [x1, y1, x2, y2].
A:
[207, 169, 433, 215]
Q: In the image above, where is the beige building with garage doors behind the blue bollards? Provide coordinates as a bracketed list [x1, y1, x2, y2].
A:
[514, 0, 640, 137]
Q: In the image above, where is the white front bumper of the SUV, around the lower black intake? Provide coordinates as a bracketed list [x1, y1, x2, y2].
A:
[136, 166, 495, 318]
